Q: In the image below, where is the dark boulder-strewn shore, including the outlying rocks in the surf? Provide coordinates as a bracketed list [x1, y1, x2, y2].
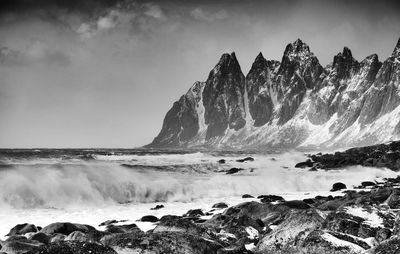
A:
[1, 142, 400, 254]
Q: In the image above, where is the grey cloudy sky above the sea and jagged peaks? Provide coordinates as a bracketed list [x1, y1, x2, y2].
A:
[0, 0, 400, 148]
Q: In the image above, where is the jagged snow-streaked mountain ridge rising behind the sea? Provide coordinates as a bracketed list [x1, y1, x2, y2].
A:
[148, 39, 400, 149]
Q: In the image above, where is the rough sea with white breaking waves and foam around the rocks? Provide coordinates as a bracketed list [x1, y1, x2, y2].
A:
[0, 149, 398, 239]
